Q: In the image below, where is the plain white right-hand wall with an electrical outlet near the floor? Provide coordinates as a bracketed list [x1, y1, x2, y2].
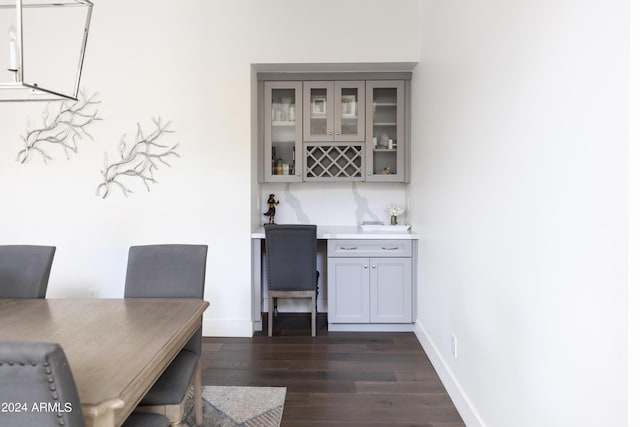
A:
[409, 0, 629, 427]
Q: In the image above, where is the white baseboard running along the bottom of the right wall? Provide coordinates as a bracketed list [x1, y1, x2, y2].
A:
[414, 320, 485, 427]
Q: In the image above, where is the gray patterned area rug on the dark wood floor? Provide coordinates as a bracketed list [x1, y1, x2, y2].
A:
[182, 386, 287, 427]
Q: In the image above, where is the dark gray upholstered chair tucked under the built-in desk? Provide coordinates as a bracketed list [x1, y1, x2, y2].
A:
[264, 224, 318, 337]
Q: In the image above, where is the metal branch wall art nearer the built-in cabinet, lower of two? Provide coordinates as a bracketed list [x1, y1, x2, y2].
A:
[96, 118, 180, 199]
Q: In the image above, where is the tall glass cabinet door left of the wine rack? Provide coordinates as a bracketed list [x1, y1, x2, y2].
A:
[264, 81, 302, 182]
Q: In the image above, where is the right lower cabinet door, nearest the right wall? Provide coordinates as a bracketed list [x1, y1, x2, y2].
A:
[369, 258, 413, 323]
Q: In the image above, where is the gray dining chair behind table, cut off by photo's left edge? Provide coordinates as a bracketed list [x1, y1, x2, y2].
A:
[0, 245, 56, 298]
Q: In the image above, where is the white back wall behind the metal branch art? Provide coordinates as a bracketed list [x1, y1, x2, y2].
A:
[0, 0, 419, 336]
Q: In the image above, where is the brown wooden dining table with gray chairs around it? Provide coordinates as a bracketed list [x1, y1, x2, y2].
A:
[0, 298, 209, 427]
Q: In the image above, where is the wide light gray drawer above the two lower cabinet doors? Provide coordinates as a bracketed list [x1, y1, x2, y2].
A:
[327, 240, 411, 257]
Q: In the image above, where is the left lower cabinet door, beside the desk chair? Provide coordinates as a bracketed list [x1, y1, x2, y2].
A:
[327, 258, 370, 323]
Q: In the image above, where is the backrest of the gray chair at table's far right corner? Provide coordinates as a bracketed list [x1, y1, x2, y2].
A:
[124, 244, 208, 354]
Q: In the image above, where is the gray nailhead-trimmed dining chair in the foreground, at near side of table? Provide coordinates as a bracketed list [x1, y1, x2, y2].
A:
[0, 341, 169, 427]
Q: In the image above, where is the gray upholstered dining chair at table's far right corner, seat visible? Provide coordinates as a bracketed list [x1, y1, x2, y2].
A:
[124, 245, 208, 426]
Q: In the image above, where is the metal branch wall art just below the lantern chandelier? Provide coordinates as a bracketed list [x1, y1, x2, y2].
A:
[17, 91, 102, 163]
